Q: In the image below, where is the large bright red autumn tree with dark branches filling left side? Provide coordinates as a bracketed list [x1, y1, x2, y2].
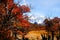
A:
[0, 0, 30, 40]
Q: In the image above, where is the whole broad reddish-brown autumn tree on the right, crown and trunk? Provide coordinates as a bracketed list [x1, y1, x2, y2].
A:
[44, 17, 60, 40]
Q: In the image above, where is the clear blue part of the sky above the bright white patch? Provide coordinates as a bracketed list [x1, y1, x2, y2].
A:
[26, 0, 60, 17]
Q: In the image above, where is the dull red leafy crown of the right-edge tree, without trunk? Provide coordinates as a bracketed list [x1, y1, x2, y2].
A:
[44, 17, 60, 31]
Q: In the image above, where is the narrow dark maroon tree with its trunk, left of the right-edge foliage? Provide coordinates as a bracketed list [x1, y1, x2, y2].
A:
[44, 19, 54, 40]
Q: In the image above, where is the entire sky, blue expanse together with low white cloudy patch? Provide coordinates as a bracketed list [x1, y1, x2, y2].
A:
[15, 0, 60, 23]
